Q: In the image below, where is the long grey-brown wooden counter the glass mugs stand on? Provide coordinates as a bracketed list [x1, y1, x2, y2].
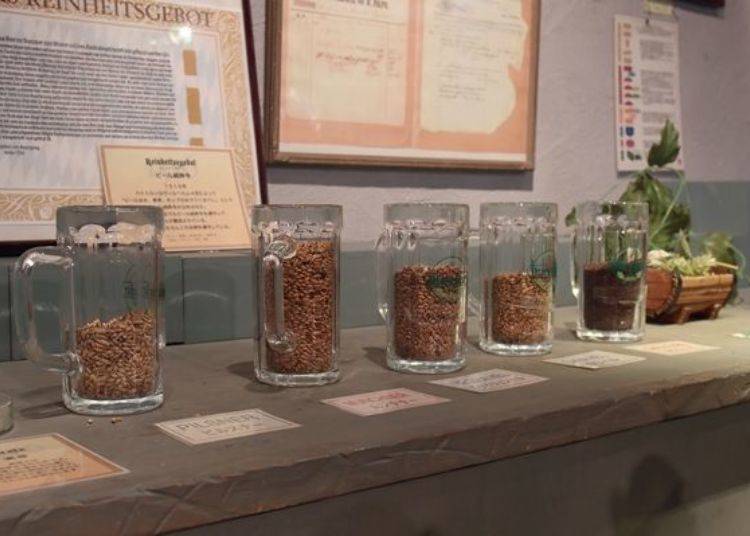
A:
[0, 308, 750, 534]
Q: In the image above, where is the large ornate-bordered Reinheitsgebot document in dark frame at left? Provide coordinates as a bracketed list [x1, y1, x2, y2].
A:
[0, 0, 266, 242]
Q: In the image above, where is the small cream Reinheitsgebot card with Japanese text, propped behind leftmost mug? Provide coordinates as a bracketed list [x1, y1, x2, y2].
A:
[101, 146, 250, 251]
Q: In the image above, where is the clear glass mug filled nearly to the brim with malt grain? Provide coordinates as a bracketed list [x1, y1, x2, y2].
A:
[252, 205, 342, 387]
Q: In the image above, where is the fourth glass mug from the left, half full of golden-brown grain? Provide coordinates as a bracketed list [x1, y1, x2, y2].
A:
[479, 203, 557, 355]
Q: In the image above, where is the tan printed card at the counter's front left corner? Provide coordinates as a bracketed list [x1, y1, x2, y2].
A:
[0, 434, 128, 495]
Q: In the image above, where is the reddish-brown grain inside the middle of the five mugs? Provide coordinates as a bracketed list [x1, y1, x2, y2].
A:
[394, 265, 466, 361]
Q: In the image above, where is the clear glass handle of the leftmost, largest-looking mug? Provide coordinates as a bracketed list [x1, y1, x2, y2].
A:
[12, 247, 78, 374]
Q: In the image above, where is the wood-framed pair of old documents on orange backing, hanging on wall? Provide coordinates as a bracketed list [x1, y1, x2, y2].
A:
[266, 0, 540, 169]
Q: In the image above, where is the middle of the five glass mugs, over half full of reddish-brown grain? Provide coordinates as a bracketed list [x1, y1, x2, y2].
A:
[376, 203, 470, 374]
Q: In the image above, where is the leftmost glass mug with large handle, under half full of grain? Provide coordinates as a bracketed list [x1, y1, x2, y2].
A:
[13, 206, 164, 415]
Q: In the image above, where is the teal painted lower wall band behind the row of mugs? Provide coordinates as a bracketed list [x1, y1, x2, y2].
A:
[0, 182, 750, 360]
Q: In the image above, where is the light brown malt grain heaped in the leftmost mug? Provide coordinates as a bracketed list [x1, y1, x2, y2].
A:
[74, 311, 158, 400]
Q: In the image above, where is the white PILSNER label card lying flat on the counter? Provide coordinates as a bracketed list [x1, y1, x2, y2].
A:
[156, 409, 300, 445]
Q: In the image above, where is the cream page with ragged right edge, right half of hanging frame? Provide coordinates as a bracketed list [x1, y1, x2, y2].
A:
[421, 0, 528, 134]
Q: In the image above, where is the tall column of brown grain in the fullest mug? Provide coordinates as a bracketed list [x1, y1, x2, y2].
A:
[265, 240, 336, 374]
